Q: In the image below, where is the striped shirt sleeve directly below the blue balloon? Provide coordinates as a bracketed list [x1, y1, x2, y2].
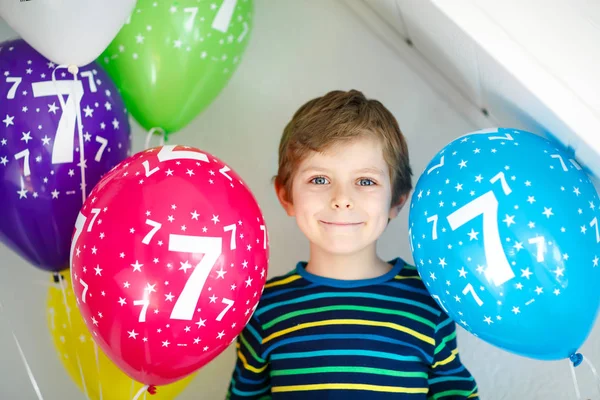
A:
[427, 312, 479, 400]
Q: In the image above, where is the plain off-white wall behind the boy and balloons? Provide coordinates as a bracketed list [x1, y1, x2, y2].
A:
[0, 0, 600, 400]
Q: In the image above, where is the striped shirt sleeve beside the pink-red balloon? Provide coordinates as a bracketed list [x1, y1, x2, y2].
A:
[227, 316, 271, 400]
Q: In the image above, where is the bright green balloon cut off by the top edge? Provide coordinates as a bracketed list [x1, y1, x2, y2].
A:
[98, 0, 253, 133]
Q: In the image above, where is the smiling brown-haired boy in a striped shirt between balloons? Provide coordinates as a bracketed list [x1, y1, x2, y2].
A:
[228, 90, 478, 400]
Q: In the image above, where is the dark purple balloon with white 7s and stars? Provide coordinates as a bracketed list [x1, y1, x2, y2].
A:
[0, 39, 131, 271]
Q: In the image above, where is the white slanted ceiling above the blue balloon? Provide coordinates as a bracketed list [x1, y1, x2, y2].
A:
[354, 0, 600, 177]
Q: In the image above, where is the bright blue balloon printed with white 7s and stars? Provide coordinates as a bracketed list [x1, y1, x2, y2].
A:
[409, 128, 600, 360]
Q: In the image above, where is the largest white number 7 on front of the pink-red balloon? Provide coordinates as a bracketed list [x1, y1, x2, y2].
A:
[169, 234, 223, 320]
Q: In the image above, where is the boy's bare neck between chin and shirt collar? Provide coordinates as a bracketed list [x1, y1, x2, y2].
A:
[306, 244, 392, 280]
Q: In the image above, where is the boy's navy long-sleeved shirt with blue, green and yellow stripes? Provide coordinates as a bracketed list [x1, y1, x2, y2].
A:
[227, 258, 478, 400]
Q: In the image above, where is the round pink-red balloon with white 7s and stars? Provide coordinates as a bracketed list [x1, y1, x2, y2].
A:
[71, 145, 269, 385]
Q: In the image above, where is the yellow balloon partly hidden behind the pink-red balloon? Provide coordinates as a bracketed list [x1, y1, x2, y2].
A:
[46, 271, 195, 400]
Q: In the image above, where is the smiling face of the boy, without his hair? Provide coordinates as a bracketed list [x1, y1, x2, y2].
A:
[277, 136, 405, 254]
